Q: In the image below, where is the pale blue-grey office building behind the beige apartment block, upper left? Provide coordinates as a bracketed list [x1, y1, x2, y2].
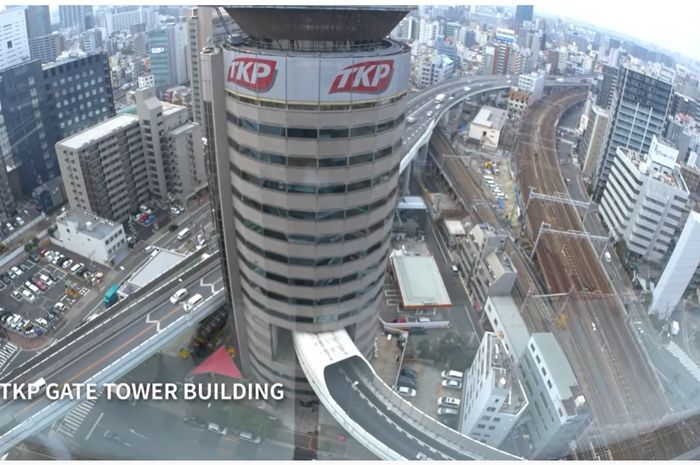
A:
[148, 22, 187, 92]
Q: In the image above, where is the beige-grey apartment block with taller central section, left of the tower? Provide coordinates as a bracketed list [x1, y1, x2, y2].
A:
[56, 87, 206, 221]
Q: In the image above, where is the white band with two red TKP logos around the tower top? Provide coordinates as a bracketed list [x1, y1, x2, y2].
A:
[224, 50, 410, 103]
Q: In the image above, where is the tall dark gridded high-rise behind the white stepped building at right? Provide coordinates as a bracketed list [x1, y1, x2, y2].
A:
[593, 62, 674, 200]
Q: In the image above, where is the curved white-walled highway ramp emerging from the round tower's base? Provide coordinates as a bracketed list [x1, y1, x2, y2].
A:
[294, 330, 521, 460]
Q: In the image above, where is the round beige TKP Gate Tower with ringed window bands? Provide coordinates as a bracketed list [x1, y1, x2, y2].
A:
[201, 7, 410, 395]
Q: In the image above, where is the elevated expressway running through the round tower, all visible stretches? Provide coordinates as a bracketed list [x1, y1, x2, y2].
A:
[0, 76, 581, 460]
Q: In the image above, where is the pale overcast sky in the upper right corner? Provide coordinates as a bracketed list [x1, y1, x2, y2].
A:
[523, 0, 700, 60]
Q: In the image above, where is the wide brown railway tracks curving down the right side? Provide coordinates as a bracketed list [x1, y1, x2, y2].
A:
[515, 93, 700, 459]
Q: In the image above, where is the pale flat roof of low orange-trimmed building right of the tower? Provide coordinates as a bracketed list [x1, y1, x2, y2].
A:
[391, 251, 452, 308]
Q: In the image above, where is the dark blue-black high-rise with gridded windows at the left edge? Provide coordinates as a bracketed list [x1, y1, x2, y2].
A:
[0, 54, 114, 195]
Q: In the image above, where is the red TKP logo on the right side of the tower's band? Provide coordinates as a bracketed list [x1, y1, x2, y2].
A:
[328, 60, 394, 94]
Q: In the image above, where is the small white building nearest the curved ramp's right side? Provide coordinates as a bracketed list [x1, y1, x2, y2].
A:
[459, 332, 528, 448]
